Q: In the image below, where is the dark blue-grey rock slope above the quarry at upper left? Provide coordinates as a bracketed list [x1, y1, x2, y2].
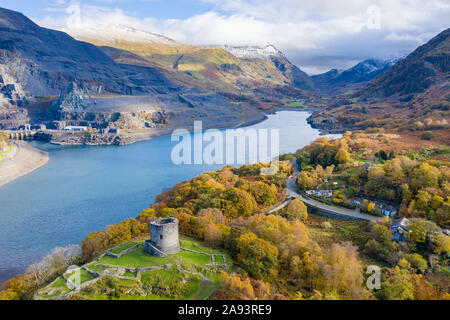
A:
[0, 8, 179, 104]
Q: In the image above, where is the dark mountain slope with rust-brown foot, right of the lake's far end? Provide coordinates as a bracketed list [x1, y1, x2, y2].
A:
[309, 29, 450, 136]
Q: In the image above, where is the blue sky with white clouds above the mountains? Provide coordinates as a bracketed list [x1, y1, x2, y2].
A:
[0, 0, 450, 74]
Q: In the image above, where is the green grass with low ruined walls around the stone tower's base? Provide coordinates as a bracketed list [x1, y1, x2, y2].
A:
[40, 236, 232, 300]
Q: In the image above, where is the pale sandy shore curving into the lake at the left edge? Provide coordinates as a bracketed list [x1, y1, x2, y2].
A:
[0, 141, 49, 187]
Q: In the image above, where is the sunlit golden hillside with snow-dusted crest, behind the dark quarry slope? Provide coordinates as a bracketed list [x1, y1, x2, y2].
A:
[73, 29, 314, 100]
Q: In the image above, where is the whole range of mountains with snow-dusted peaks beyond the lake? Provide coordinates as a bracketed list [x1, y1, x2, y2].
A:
[0, 5, 449, 144]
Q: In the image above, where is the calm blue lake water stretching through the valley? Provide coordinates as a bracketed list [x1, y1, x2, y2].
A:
[0, 111, 337, 282]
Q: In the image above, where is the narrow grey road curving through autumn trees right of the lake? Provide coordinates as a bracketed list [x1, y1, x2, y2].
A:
[286, 158, 379, 221]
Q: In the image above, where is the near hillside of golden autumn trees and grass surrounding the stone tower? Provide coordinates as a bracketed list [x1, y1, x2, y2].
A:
[0, 132, 450, 300]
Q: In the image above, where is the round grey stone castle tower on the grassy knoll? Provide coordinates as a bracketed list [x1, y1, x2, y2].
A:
[144, 218, 180, 257]
